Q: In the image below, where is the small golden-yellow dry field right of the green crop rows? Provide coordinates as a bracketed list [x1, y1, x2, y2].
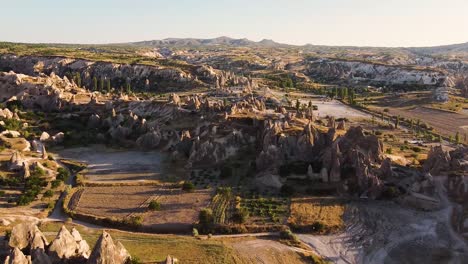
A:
[288, 197, 345, 233]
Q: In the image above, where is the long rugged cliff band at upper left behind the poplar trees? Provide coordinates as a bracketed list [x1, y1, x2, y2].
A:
[0, 54, 252, 90]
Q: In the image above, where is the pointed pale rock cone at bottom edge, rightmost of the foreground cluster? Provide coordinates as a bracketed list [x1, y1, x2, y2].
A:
[87, 231, 131, 264]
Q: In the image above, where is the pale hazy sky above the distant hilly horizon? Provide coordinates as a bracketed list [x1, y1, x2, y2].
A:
[0, 0, 468, 46]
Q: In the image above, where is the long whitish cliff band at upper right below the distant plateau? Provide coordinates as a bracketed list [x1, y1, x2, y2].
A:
[305, 59, 449, 87]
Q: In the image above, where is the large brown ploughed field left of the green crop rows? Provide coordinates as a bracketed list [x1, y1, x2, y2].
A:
[71, 186, 211, 232]
